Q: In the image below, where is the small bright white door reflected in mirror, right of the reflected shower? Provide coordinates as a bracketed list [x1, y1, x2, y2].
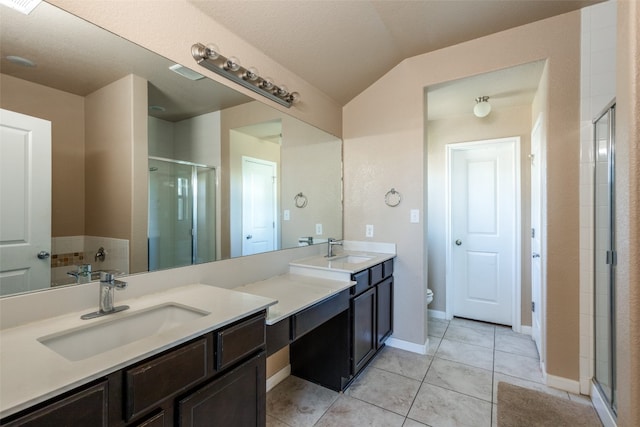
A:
[242, 156, 277, 255]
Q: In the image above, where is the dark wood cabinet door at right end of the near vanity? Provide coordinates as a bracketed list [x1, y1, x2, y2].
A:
[178, 353, 267, 427]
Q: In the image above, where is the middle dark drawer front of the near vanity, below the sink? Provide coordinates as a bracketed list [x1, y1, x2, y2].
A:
[124, 338, 211, 420]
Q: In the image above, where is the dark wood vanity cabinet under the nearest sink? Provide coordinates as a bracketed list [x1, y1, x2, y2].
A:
[0, 311, 266, 427]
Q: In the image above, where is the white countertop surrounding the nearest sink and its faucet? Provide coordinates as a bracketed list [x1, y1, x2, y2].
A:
[0, 284, 277, 418]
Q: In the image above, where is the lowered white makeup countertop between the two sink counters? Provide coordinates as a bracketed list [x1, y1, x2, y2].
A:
[234, 274, 355, 325]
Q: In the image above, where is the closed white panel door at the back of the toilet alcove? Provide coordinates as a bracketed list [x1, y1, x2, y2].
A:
[447, 138, 520, 325]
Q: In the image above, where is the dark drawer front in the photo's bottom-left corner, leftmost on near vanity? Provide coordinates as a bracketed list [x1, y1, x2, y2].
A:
[2, 381, 108, 427]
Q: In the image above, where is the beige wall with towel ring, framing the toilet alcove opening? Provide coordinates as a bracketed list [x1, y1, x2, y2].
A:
[343, 12, 580, 381]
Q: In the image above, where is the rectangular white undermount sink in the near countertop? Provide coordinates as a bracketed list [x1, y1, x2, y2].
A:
[38, 303, 210, 362]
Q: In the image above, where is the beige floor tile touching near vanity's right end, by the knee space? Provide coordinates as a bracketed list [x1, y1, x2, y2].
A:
[267, 376, 339, 427]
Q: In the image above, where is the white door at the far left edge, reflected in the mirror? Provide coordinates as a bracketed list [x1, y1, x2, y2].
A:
[0, 109, 51, 295]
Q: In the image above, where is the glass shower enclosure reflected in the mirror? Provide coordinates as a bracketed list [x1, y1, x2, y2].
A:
[148, 157, 216, 271]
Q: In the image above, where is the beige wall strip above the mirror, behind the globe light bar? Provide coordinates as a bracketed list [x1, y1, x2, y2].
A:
[49, 0, 342, 136]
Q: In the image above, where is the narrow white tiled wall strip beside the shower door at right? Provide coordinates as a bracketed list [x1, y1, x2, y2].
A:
[580, 0, 617, 394]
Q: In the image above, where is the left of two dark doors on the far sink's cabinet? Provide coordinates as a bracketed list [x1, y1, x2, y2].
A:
[351, 287, 377, 375]
